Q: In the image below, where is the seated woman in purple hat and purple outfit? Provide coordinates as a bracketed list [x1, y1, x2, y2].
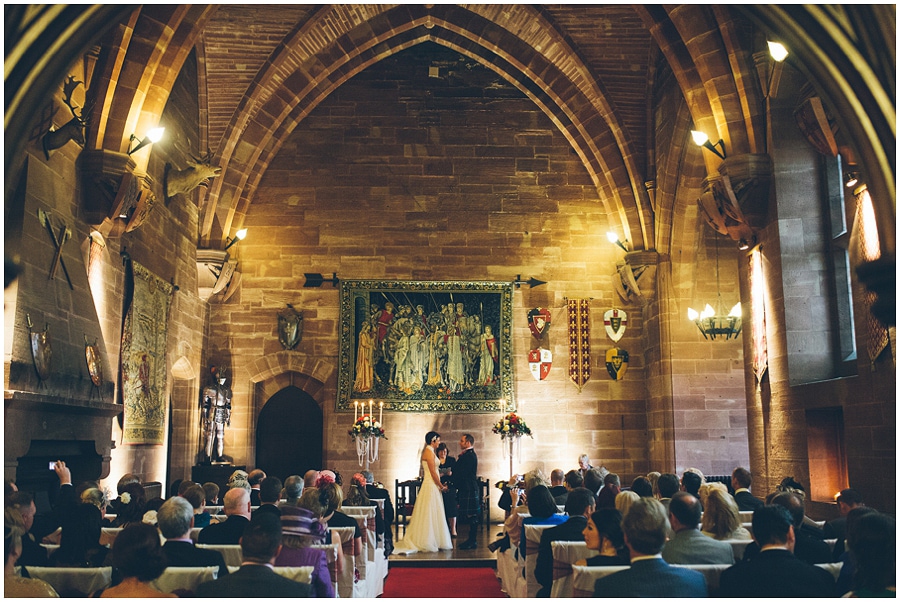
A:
[274, 502, 335, 598]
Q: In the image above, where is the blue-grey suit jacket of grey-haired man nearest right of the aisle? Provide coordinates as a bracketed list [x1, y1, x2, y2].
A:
[594, 558, 707, 598]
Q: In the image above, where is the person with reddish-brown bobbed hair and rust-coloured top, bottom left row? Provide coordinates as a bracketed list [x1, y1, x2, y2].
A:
[100, 523, 178, 598]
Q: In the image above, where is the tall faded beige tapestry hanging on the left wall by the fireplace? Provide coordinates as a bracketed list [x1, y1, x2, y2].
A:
[121, 261, 174, 445]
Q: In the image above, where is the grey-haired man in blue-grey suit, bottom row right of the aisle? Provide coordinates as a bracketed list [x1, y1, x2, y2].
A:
[594, 494, 712, 598]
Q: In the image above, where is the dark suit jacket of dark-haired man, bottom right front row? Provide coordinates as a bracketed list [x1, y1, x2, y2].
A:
[719, 550, 836, 598]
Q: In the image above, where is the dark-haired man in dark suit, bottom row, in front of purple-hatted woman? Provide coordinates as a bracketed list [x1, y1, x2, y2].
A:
[197, 510, 312, 598]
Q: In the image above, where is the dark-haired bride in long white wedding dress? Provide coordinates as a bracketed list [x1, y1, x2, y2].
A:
[394, 431, 453, 554]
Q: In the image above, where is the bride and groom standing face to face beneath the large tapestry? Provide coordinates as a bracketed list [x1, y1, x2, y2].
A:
[394, 431, 481, 554]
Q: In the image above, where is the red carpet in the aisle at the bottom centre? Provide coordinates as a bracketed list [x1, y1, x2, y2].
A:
[382, 567, 506, 598]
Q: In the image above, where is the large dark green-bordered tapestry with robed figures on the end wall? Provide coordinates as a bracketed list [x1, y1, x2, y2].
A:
[337, 280, 515, 412]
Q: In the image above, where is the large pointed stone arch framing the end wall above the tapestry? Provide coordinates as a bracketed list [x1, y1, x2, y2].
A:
[201, 5, 654, 248]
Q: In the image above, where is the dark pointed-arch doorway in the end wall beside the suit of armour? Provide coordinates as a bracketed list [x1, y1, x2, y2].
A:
[256, 386, 322, 481]
